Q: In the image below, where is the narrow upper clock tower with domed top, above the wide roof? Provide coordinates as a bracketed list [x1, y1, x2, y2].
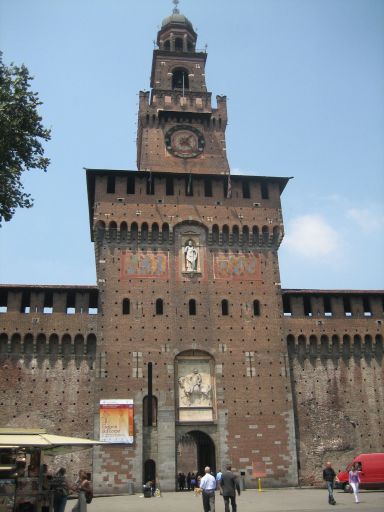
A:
[137, 2, 229, 174]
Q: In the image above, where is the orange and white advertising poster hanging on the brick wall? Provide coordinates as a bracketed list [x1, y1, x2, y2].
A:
[100, 399, 133, 444]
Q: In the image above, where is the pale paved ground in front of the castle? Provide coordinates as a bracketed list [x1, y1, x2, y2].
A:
[83, 489, 384, 512]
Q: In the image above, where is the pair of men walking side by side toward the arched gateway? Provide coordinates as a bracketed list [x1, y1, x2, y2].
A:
[199, 464, 240, 512]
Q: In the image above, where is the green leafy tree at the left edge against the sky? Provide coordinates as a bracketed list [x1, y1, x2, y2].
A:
[0, 53, 51, 226]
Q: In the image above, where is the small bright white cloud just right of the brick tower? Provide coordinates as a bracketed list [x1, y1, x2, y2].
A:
[284, 214, 341, 260]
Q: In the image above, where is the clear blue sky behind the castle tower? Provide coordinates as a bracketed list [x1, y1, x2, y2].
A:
[0, 0, 384, 289]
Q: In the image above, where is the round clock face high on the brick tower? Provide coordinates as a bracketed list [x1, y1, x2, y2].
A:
[164, 125, 205, 158]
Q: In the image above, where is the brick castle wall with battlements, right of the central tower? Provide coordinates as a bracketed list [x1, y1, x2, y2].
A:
[283, 290, 384, 485]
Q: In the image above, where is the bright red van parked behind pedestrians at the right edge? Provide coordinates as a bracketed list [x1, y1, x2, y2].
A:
[336, 453, 384, 492]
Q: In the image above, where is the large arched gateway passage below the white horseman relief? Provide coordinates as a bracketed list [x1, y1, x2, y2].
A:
[176, 430, 216, 476]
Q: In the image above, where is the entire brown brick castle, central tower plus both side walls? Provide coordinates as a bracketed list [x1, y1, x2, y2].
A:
[0, 2, 384, 493]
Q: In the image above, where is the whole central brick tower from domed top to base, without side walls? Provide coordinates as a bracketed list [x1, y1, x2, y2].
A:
[87, 2, 297, 491]
